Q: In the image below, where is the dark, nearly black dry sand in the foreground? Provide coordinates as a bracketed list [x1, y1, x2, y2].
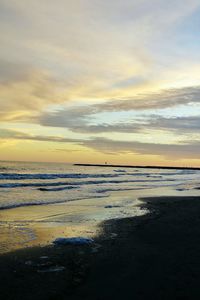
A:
[0, 197, 200, 300]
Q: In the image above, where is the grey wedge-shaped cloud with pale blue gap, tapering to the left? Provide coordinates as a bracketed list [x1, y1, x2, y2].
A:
[36, 87, 200, 134]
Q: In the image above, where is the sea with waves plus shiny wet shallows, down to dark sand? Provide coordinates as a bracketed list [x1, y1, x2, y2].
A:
[0, 161, 200, 253]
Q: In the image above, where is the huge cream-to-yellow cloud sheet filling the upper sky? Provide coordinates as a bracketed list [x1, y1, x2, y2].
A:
[0, 0, 199, 123]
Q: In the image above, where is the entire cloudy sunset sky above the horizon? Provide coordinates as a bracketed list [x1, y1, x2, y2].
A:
[0, 0, 200, 166]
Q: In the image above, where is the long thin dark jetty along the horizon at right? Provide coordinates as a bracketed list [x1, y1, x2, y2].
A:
[74, 164, 200, 170]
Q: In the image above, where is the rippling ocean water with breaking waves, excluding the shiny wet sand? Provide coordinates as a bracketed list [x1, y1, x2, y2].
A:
[0, 162, 200, 209]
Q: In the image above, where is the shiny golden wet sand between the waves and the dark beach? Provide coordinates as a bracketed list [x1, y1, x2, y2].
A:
[0, 191, 146, 254]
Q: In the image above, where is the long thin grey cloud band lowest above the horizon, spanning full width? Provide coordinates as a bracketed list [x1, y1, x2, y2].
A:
[0, 129, 200, 160]
